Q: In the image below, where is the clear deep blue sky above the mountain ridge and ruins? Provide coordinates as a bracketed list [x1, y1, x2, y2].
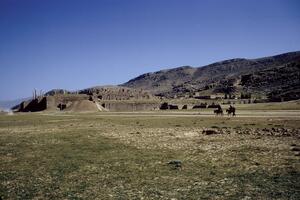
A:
[0, 0, 300, 100]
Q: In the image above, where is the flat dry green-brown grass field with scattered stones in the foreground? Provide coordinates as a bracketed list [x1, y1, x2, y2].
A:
[0, 103, 300, 199]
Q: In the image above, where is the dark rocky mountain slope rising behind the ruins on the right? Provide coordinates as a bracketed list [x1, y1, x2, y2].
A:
[121, 51, 300, 98]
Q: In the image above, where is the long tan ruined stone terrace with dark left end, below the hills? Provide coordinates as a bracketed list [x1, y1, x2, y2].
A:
[18, 87, 160, 112]
